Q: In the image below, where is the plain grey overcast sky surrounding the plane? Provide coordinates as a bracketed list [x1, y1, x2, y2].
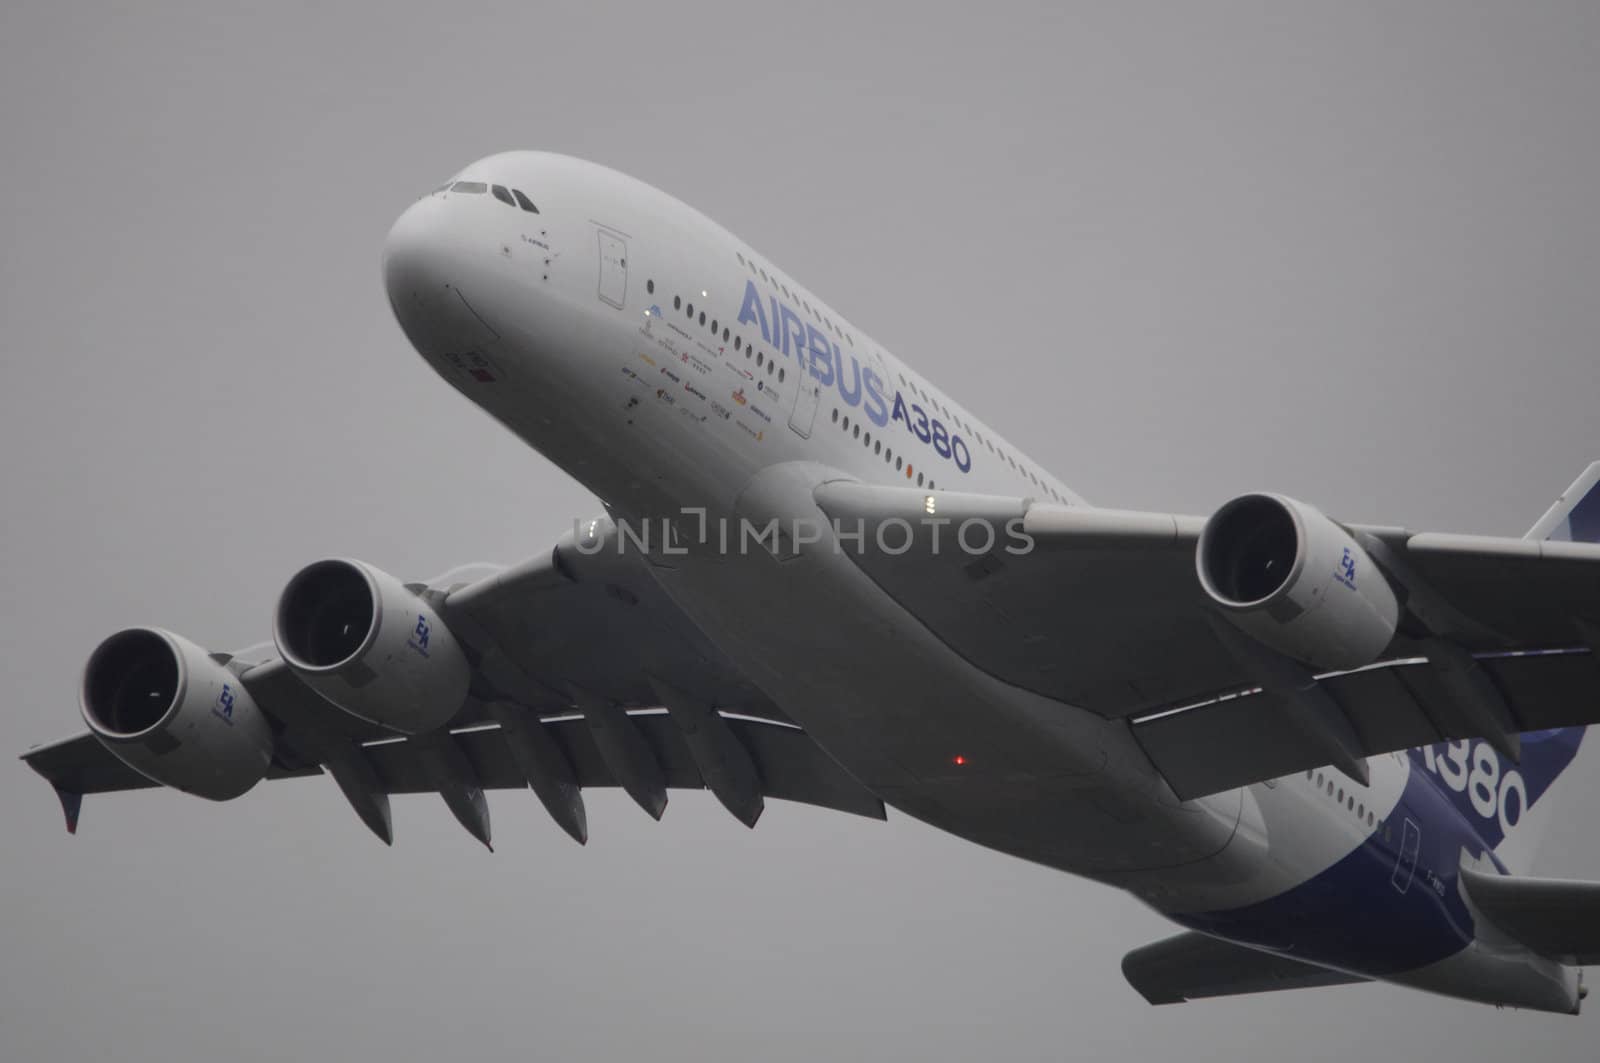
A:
[0, 0, 1600, 1063]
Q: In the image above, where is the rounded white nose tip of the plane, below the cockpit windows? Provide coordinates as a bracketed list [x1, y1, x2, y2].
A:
[384, 195, 496, 359]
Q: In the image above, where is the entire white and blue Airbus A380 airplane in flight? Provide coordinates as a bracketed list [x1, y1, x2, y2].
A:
[22, 152, 1600, 1013]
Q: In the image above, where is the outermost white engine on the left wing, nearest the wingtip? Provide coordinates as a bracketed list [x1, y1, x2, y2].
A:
[78, 628, 272, 800]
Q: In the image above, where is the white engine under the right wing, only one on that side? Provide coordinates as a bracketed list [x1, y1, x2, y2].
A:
[1195, 495, 1400, 671]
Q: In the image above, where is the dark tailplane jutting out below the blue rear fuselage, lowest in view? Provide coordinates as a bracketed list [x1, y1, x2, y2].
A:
[1122, 932, 1368, 1004]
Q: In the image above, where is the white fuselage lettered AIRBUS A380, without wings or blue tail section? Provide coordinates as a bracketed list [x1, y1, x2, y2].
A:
[386, 152, 1573, 1007]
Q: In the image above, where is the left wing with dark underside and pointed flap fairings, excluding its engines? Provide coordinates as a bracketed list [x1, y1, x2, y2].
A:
[22, 541, 885, 844]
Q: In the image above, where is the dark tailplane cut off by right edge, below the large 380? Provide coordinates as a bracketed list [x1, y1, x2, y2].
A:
[1461, 868, 1600, 967]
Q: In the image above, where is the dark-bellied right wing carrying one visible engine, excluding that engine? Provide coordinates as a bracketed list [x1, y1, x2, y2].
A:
[814, 480, 1600, 797]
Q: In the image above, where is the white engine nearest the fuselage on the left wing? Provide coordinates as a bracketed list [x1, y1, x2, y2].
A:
[272, 560, 472, 735]
